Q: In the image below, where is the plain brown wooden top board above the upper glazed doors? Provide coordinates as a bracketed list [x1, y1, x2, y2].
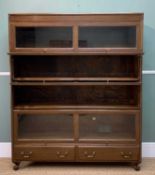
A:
[9, 13, 144, 22]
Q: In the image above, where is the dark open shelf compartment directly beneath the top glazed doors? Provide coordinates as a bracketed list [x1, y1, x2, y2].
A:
[13, 55, 140, 78]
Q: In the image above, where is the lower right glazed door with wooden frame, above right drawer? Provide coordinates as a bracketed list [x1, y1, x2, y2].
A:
[79, 111, 140, 144]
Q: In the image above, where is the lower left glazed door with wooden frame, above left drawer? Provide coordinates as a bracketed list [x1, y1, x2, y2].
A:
[14, 110, 74, 143]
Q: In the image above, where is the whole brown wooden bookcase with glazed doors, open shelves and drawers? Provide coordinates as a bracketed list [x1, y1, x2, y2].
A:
[9, 13, 143, 170]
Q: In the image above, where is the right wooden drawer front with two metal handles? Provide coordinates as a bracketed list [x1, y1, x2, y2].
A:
[77, 146, 140, 162]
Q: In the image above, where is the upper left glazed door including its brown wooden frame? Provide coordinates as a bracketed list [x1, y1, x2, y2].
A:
[10, 23, 73, 53]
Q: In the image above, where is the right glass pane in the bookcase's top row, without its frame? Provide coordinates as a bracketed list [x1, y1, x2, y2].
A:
[79, 26, 136, 48]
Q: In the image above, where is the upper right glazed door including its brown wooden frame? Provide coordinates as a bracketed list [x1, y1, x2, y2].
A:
[78, 23, 141, 54]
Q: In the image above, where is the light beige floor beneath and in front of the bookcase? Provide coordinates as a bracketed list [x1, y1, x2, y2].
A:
[0, 158, 155, 175]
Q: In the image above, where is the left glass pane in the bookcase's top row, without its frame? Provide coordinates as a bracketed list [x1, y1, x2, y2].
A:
[16, 27, 72, 48]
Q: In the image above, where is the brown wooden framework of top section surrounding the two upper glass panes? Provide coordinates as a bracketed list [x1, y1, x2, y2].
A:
[9, 14, 143, 54]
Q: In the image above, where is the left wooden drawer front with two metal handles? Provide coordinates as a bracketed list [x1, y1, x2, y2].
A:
[13, 147, 75, 161]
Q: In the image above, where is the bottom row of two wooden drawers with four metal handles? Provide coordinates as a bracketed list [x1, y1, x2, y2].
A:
[13, 146, 140, 162]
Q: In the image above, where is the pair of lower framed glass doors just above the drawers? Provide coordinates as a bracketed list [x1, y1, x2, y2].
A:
[13, 110, 141, 145]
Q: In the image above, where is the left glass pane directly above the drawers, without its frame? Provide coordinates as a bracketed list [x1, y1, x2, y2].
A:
[18, 114, 73, 139]
